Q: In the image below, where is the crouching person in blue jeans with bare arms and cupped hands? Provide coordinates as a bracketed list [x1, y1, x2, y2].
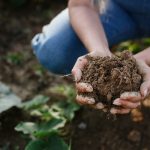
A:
[32, 0, 150, 114]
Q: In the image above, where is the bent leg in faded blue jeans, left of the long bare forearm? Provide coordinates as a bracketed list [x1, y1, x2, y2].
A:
[32, 9, 87, 74]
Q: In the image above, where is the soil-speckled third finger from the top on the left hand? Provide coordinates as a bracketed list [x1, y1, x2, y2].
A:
[76, 95, 95, 105]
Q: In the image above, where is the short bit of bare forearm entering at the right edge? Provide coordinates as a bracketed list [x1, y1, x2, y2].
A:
[134, 47, 150, 66]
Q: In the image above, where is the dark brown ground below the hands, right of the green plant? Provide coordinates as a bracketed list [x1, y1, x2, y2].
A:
[72, 107, 150, 150]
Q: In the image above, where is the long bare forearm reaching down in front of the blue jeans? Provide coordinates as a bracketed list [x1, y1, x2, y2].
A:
[69, 0, 110, 55]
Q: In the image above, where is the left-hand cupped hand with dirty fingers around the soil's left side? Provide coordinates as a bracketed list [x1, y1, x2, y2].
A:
[72, 51, 112, 111]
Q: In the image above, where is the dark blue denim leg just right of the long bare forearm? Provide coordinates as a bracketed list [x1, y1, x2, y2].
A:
[100, 0, 140, 47]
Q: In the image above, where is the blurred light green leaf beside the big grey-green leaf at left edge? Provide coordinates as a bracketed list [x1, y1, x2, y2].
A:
[21, 95, 49, 110]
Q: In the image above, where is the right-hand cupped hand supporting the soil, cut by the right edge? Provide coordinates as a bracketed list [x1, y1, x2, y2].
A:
[110, 59, 150, 114]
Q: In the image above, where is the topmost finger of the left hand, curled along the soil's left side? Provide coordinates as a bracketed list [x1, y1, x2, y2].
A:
[72, 56, 88, 82]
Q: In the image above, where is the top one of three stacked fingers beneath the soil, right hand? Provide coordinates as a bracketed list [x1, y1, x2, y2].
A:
[120, 92, 143, 102]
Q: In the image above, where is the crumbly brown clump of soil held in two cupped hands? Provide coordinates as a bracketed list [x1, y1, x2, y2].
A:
[79, 51, 142, 106]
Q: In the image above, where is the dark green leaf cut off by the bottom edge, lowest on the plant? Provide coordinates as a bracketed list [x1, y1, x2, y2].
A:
[25, 134, 69, 150]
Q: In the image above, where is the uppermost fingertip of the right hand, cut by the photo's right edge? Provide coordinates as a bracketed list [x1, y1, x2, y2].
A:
[140, 81, 150, 98]
